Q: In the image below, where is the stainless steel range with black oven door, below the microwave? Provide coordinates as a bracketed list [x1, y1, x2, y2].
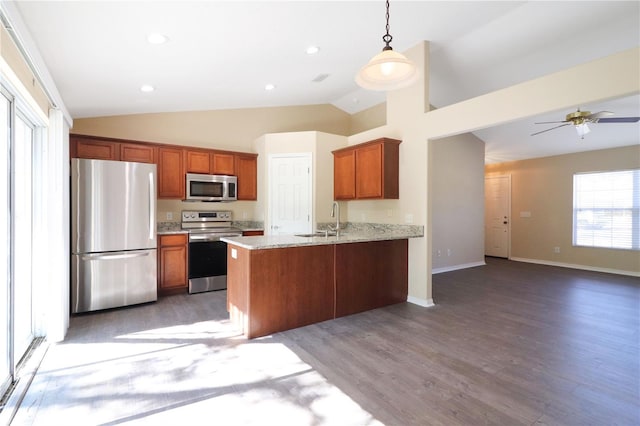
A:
[182, 210, 242, 293]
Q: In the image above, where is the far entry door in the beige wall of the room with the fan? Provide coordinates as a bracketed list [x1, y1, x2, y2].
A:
[484, 176, 511, 258]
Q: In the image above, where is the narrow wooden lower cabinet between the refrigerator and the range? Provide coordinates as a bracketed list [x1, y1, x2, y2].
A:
[158, 234, 189, 296]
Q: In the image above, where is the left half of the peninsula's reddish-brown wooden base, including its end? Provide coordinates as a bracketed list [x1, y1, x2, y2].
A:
[227, 245, 334, 338]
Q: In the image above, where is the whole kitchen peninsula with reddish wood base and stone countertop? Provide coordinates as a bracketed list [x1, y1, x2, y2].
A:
[222, 225, 423, 338]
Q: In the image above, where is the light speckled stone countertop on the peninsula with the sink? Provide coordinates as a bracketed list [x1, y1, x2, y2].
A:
[220, 225, 424, 250]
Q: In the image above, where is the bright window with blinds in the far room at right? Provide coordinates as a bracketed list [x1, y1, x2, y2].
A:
[573, 169, 640, 250]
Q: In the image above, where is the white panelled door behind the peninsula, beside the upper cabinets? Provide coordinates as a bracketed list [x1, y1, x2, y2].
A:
[268, 153, 312, 235]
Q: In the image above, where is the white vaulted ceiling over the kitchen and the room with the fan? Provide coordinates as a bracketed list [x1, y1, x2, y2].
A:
[10, 0, 640, 162]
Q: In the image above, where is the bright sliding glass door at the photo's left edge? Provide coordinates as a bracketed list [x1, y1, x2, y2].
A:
[0, 86, 34, 395]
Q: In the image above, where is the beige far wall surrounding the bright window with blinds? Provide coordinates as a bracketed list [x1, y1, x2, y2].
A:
[485, 145, 640, 274]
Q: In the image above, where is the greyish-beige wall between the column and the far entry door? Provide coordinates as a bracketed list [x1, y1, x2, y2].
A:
[431, 133, 484, 272]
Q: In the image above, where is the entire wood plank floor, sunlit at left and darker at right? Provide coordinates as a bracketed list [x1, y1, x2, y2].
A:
[16, 258, 640, 426]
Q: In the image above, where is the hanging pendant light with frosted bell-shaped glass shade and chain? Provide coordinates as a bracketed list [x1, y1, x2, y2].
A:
[356, 0, 418, 90]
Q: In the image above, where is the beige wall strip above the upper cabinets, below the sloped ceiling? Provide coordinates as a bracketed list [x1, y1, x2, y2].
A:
[71, 105, 350, 152]
